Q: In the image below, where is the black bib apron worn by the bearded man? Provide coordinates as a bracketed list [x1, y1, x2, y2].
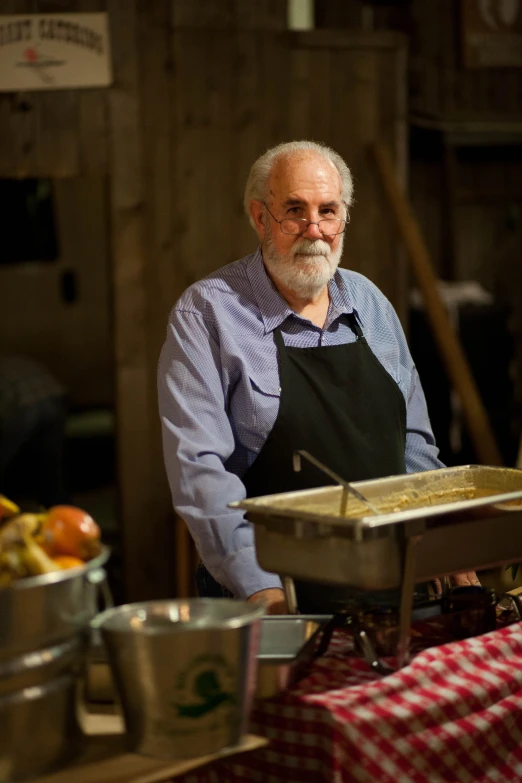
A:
[197, 314, 406, 613]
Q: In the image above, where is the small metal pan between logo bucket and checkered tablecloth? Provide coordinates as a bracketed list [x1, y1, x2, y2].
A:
[256, 615, 331, 699]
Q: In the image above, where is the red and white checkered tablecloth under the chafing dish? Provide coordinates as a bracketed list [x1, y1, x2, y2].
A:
[183, 623, 522, 783]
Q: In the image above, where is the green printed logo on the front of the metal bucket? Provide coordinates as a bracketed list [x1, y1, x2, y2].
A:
[171, 655, 236, 718]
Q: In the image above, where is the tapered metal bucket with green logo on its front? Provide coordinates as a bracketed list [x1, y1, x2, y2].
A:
[92, 598, 264, 758]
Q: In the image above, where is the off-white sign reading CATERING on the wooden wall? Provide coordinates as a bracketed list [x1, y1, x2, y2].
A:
[0, 14, 112, 92]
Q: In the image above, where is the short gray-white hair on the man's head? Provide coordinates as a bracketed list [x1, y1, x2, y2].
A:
[243, 141, 353, 230]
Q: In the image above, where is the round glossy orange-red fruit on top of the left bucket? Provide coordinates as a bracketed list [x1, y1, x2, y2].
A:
[40, 506, 101, 561]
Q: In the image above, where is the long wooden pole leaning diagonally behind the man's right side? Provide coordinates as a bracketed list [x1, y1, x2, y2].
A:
[373, 143, 502, 465]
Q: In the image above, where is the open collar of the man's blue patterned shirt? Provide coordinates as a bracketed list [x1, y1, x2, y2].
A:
[247, 247, 353, 334]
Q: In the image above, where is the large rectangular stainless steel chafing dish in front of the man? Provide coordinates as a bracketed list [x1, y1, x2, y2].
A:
[230, 465, 522, 666]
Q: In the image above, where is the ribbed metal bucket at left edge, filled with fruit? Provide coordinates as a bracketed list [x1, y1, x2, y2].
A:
[0, 548, 109, 783]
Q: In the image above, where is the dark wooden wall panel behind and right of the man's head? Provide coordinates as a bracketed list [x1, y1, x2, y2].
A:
[291, 30, 407, 322]
